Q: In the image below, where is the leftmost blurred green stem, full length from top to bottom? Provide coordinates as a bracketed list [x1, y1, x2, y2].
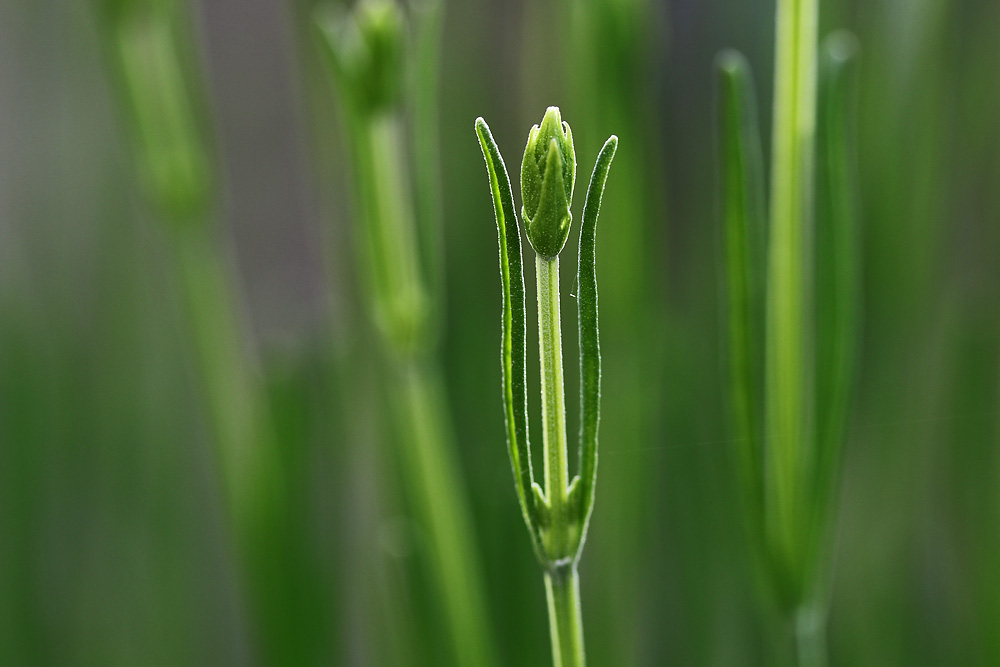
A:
[103, 2, 292, 663]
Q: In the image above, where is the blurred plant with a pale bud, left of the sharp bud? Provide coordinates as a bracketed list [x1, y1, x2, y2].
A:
[315, 0, 496, 666]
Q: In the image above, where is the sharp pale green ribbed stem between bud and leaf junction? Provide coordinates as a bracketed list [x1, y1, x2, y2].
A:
[535, 255, 569, 532]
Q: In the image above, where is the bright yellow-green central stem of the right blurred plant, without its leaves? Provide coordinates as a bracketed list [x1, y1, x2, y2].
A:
[765, 0, 818, 595]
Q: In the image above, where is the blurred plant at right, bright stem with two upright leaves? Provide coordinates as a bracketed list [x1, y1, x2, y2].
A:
[716, 0, 861, 665]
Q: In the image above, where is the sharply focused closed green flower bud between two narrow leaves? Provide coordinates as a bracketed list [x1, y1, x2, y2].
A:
[521, 107, 576, 259]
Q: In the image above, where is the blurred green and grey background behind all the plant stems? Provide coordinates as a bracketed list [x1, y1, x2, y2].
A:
[0, 0, 1000, 666]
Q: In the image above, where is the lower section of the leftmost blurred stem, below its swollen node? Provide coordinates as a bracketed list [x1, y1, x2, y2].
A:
[172, 220, 294, 663]
